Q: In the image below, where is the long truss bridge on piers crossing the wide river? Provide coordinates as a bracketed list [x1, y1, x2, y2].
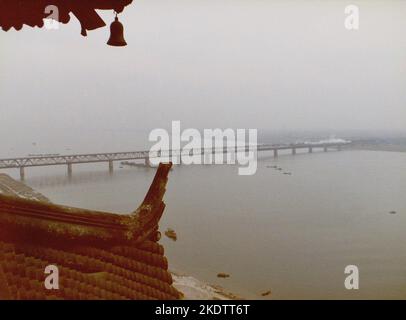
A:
[0, 142, 349, 180]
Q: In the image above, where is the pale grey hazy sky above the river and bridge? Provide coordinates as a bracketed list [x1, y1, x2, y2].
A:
[0, 0, 406, 152]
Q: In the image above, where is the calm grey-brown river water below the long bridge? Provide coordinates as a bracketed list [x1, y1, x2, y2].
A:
[0, 150, 406, 299]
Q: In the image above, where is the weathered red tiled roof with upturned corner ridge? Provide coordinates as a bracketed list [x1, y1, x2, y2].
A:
[0, 164, 181, 299]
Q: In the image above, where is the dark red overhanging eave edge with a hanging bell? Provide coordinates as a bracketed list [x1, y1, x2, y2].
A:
[0, 0, 132, 46]
